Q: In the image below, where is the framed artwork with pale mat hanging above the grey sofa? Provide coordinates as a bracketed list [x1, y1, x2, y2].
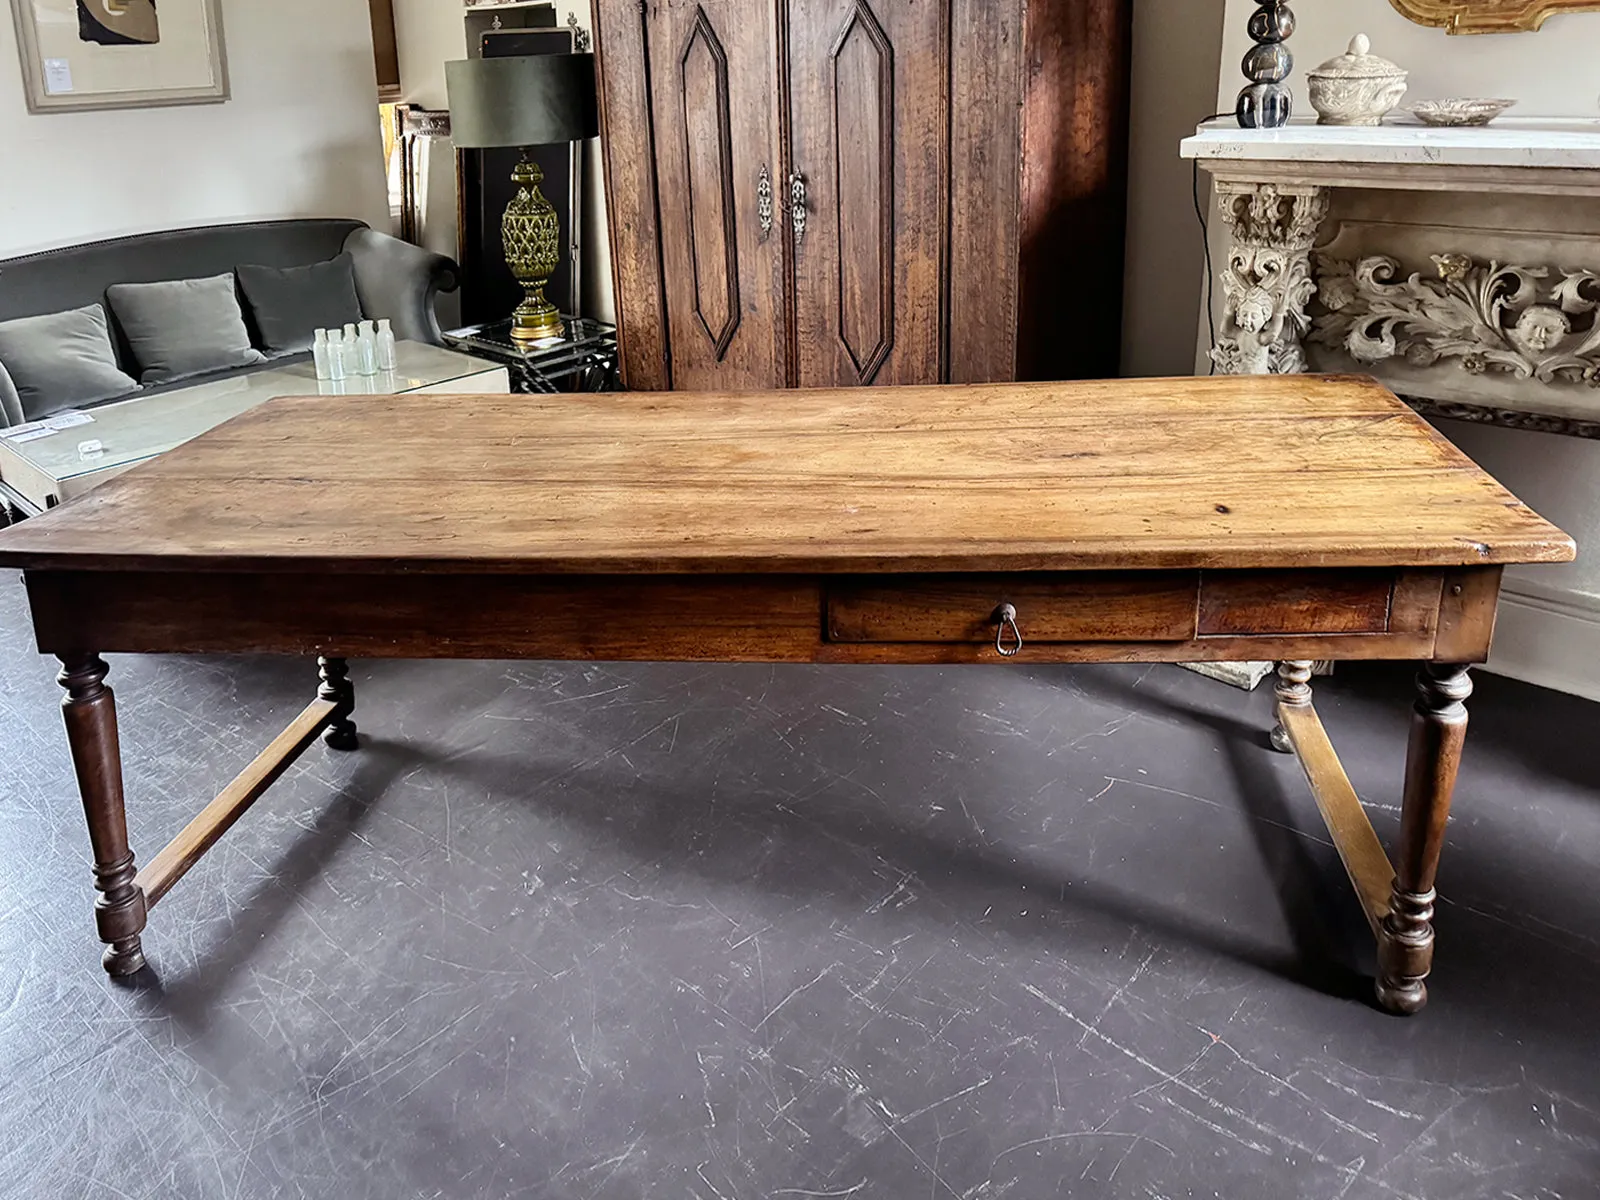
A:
[11, 0, 227, 112]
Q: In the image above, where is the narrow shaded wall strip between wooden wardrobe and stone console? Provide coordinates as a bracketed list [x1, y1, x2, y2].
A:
[1122, 0, 1222, 374]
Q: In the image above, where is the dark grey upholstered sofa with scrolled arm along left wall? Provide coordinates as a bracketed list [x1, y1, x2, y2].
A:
[0, 218, 461, 426]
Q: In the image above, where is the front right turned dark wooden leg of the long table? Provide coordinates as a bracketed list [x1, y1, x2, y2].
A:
[1378, 662, 1472, 1014]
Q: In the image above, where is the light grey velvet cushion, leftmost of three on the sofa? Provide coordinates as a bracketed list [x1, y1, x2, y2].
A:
[0, 304, 139, 421]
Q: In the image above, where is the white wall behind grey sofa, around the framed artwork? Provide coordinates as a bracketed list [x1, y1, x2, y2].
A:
[0, 0, 389, 254]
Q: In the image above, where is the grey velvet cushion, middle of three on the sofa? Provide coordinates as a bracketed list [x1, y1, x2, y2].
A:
[106, 275, 267, 384]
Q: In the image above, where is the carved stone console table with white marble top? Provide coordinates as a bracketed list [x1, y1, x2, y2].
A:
[1182, 117, 1600, 437]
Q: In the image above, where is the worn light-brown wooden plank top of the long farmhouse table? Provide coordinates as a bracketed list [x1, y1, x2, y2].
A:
[0, 376, 1574, 574]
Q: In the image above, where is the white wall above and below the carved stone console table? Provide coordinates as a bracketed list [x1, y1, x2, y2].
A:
[1203, 0, 1600, 699]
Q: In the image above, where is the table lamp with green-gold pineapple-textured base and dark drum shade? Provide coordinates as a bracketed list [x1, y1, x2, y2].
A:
[445, 54, 600, 344]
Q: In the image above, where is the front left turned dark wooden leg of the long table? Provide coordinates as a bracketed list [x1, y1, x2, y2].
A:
[59, 654, 146, 976]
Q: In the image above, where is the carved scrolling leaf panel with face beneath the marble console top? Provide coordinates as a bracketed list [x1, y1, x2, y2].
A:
[1310, 254, 1600, 387]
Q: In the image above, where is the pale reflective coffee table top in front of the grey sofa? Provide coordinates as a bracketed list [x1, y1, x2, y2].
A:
[0, 341, 498, 482]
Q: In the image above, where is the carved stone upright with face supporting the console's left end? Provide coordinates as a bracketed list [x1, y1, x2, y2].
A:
[1211, 184, 1328, 374]
